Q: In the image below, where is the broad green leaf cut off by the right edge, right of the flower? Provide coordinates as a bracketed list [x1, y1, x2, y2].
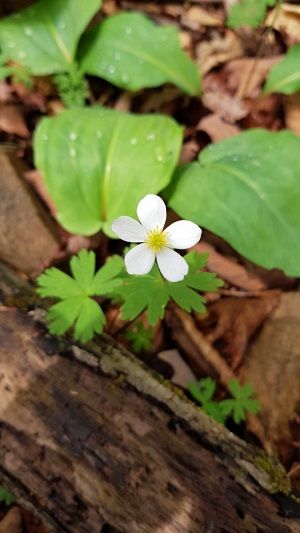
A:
[167, 129, 300, 276]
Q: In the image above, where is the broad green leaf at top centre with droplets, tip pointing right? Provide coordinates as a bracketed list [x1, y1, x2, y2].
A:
[79, 13, 200, 95]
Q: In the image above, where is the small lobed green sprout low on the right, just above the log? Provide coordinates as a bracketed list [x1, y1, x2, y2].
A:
[188, 377, 260, 424]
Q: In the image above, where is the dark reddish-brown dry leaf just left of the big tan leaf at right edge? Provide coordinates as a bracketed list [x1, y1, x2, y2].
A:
[207, 292, 279, 369]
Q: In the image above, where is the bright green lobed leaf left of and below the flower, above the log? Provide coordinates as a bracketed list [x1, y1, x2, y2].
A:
[37, 250, 123, 343]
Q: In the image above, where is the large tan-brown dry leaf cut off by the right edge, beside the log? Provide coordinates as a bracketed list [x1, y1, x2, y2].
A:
[242, 292, 300, 464]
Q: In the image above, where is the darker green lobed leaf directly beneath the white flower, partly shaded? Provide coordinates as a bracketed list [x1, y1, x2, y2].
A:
[117, 252, 222, 326]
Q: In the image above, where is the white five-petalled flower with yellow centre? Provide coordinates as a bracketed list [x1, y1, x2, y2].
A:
[112, 194, 202, 281]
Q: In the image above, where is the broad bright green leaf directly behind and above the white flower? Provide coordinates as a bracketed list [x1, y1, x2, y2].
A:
[34, 108, 182, 235]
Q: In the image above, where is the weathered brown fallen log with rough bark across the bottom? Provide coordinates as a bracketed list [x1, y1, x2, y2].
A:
[0, 265, 300, 533]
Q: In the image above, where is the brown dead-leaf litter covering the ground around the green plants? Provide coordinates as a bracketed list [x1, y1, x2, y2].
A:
[0, 0, 300, 533]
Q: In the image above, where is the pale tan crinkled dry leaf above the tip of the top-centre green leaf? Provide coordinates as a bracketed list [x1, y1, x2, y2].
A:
[196, 30, 244, 76]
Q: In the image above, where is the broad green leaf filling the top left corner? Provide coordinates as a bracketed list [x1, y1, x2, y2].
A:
[0, 0, 102, 75]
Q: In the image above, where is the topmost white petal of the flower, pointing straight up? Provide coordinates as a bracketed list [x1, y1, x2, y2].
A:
[136, 194, 167, 230]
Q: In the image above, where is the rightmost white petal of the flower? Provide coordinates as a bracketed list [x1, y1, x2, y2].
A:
[164, 220, 202, 250]
